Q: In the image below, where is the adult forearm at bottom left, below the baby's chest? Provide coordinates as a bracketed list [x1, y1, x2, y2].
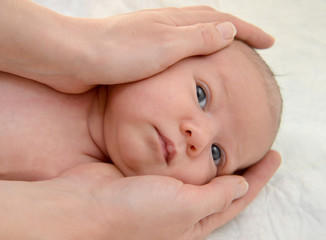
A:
[0, 181, 107, 240]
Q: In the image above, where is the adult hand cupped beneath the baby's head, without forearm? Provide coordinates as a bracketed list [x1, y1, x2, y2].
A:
[54, 151, 280, 240]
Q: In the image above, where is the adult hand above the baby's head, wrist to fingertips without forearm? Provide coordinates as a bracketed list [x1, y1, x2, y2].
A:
[76, 6, 274, 91]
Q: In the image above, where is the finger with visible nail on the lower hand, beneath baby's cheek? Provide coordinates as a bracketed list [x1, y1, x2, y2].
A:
[183, 175, 248, 219]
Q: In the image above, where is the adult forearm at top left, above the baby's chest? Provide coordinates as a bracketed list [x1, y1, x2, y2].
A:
[0, 0, 92, 92]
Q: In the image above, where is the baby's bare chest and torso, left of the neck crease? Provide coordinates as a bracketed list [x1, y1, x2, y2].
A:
[0, 73, 105, 180]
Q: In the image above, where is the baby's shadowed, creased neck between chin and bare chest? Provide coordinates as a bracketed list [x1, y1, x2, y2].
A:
[87, 86, 109, 159]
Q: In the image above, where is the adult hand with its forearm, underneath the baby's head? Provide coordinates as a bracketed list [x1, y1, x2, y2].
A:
[0, 151, 280, 240]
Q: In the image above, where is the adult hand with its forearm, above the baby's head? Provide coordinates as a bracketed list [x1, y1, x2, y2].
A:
[0, 0, 273, 93]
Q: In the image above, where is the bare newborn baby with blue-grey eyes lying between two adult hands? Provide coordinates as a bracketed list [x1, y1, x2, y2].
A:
[0, 41, 281, 185]
